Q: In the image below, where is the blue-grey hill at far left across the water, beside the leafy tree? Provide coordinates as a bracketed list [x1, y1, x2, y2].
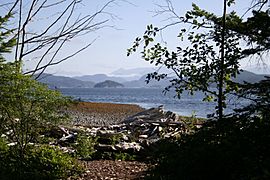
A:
[38, 74, 94, 88]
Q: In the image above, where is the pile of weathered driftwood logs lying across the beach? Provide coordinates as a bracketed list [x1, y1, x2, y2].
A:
[50, 106, 192, 155]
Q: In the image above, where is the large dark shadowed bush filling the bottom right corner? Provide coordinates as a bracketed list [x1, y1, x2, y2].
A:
[147, 117, 270, 180]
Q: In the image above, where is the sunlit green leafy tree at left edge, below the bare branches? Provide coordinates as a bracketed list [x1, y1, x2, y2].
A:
[0, 14, 68, 176]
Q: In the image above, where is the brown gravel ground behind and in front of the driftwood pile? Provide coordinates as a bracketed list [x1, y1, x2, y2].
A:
[66, 102, 151, 180]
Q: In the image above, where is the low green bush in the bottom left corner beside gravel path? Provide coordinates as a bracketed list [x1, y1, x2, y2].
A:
[0, 146, 82, 179]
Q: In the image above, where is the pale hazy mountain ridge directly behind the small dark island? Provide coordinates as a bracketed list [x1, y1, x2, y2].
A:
[73, 74, 127, 83]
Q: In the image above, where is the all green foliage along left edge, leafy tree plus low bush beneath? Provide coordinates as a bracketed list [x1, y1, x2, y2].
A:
[0, 13, 73, 179]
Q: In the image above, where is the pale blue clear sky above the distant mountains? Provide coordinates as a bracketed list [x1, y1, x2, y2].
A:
[3, 0, 268, 76]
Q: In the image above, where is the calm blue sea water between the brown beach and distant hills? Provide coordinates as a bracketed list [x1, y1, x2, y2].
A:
[60, 88, 249, 117]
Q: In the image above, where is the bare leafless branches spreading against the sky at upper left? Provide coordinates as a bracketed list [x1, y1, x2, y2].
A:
[0, 0, 120, 78]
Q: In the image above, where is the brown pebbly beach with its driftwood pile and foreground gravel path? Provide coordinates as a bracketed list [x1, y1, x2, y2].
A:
[59, 102, 195, 179]
